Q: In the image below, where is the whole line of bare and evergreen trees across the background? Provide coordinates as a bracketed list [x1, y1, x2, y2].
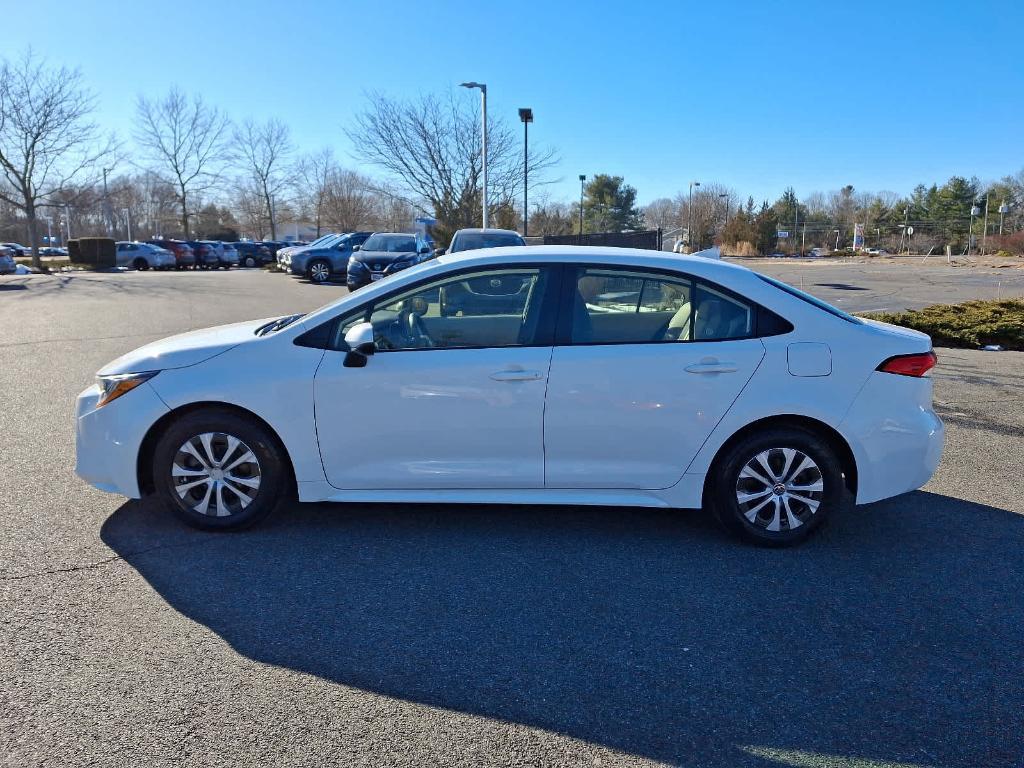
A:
[0, 51, 1024, 265]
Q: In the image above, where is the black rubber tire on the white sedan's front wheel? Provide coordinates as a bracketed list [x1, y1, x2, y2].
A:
[152, 408, 292, 530]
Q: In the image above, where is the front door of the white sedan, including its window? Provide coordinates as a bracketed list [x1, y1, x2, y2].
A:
[313, 267, 554, 489]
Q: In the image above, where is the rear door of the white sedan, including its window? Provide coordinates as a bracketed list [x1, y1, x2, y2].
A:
[544, 266, 765, 489]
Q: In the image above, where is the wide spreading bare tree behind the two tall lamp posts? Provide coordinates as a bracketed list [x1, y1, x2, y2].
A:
[348, 94, 555, 239]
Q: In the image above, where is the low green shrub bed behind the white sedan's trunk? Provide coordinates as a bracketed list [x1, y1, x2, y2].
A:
[864, 299, 1024, 350]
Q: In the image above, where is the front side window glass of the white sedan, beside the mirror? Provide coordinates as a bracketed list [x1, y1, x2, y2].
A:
[332, 267, 548, 352]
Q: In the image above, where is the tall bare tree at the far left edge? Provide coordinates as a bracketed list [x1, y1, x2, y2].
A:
[0, 50, 117, 269]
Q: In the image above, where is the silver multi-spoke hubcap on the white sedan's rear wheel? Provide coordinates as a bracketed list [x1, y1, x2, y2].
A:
[736, 449, 824, 530]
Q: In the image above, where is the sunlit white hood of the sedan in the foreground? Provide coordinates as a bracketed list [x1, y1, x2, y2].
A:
[97, 317, 273, 376]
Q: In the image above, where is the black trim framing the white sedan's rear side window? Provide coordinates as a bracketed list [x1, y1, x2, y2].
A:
[555, 261, 794, 347]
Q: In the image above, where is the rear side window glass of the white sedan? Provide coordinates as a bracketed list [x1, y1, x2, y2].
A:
[570, 267, 754, 344]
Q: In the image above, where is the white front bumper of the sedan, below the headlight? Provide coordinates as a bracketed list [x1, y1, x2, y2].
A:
[75, 382, 170, 499]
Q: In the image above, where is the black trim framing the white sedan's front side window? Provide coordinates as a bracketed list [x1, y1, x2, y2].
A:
[293, 261, 563, 354]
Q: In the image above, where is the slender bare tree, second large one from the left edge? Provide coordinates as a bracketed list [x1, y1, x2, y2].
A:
[135, 88, 230, 239]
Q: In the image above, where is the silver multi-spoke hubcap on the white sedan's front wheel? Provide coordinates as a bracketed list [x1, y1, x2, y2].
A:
[171, 432, 260, 517]
